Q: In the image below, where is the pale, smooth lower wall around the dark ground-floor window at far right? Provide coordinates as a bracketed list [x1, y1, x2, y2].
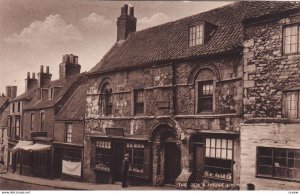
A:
[240, 122, 300, 190]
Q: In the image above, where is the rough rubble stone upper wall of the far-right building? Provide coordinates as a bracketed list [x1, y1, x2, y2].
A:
[243, 15, 300, 118]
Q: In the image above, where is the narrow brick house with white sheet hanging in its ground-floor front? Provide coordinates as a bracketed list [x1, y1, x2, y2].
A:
[53, 82, 86, 181]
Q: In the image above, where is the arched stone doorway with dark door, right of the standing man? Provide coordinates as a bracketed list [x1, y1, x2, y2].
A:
[151, 124, 181, 185]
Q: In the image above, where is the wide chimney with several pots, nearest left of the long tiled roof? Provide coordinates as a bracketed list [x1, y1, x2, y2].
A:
[59, 54, 81, 79]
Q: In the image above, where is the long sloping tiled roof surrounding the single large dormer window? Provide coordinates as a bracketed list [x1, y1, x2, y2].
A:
[90, 1, 298, 74]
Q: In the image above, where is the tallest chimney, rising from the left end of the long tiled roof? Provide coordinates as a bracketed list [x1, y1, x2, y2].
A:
[117, 4, 136, 41]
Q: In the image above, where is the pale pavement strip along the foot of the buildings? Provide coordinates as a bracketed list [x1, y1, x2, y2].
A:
[0, 172, 175, 190]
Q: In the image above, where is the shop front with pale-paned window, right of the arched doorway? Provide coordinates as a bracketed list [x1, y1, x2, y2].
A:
[190, 132, 238, 185]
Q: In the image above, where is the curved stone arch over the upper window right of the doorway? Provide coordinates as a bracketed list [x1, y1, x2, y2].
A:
[188, 61, 220, 85]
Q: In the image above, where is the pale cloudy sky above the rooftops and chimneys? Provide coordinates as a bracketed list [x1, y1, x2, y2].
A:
[0, 0, 230, 94]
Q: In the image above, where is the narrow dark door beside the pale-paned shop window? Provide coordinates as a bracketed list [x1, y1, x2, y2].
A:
[194, 144, 204, 181]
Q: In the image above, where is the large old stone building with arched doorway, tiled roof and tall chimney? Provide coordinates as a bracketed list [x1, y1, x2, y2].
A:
[84, 2, 249, 187]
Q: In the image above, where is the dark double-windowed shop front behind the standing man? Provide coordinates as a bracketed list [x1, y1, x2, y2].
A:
[92, 129, 151, 185]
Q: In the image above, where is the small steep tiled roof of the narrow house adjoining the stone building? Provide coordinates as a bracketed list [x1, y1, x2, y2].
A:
[55, 83, 87, 120]
